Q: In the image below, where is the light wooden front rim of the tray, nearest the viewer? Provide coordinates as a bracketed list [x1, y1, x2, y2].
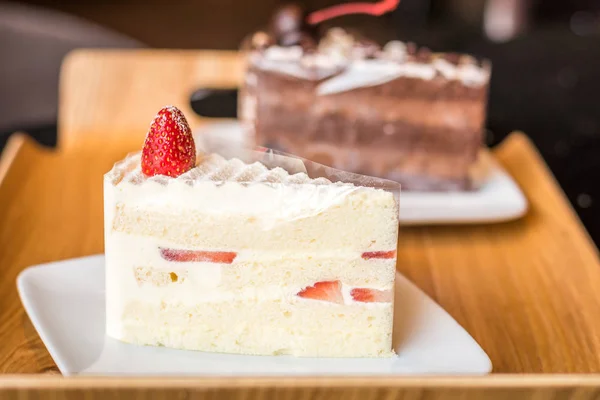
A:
[0, 374, 600, 391]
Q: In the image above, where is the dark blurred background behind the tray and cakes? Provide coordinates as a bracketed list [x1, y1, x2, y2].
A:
[0, 0, 600, 244]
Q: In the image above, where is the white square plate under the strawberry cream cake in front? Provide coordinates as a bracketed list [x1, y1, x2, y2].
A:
[17, 255, 492, 377]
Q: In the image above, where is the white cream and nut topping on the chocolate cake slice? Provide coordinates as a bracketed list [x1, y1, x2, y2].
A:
[251, 28, 490, 95]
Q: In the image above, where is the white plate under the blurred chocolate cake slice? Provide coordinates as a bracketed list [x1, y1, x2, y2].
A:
[194, 121, 527, 225]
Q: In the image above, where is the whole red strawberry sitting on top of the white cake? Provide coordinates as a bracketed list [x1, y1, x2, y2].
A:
[142, 106, 196, 177]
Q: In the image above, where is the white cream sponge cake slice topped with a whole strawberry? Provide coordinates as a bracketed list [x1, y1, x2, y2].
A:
[104, 107, 398, 357]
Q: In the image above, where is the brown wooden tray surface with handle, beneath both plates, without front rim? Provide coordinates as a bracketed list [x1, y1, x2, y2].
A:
[0, 50, 600, 396]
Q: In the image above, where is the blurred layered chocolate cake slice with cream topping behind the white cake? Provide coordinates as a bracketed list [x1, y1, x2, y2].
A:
[238, 28, 490, 191]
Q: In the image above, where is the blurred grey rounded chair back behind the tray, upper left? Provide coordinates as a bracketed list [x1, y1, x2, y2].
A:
[0, 3, 145, 149]
